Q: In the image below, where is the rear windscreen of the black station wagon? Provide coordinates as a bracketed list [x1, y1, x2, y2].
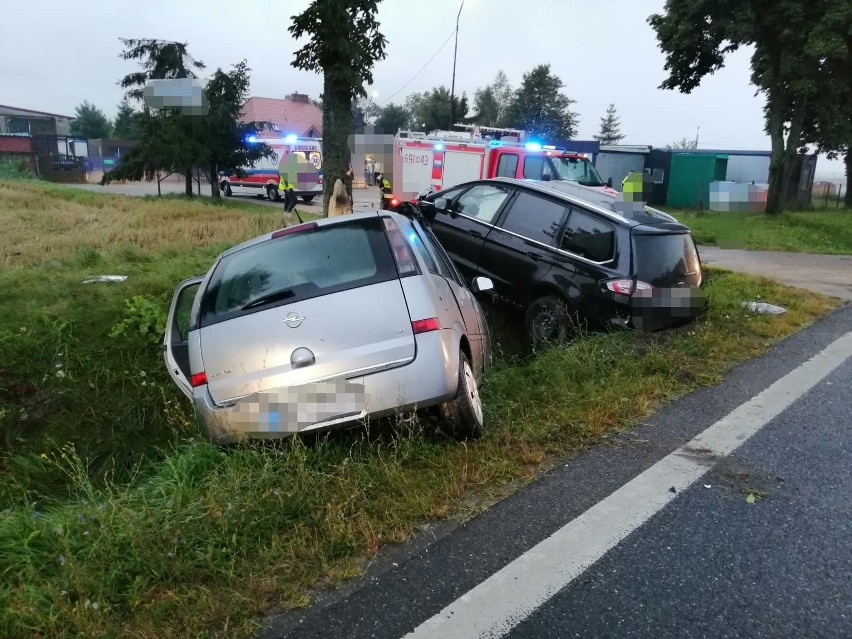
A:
[633, 233, 701, 285]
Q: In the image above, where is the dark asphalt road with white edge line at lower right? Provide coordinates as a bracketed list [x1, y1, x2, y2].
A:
[260, 306, 852, 639]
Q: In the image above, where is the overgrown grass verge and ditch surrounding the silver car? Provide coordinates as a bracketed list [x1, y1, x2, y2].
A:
[0, 178, 835, 638]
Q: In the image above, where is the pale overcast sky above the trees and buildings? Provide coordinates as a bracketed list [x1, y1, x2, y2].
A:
[0, 0, 843, 177]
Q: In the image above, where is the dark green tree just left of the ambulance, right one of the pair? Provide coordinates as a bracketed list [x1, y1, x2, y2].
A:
[197, 60, 275, 198]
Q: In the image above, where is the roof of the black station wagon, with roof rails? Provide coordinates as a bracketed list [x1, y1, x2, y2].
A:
[480, 178, 689, 231]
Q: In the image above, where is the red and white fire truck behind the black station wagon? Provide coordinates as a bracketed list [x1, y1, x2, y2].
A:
[392, 124, 617, 201]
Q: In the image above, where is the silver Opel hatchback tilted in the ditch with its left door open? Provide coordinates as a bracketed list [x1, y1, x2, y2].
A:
[163, 211, 493, 443]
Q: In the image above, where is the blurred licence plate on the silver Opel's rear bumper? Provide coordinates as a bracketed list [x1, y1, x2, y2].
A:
[234, 381, 366, 433]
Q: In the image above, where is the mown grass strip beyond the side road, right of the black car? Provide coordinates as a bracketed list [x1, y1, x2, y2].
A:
[668, 209, 852, 255]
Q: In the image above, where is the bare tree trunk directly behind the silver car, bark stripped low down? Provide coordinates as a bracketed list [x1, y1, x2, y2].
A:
[322, 76, 352, 217]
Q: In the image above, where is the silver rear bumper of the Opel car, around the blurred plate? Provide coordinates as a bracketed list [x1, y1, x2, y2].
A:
[193, 329, 459, 444]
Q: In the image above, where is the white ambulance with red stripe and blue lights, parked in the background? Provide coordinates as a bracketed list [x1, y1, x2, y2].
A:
[219, 135, 322, 202]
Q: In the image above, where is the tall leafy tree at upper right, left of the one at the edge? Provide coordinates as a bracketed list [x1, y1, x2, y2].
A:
[648, 0, 825, 214]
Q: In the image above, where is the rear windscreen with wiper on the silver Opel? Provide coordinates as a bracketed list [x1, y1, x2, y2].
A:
[200, 218, 399, 326]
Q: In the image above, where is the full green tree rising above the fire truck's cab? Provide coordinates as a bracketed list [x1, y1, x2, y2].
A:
[508, 64, 578, 140]
